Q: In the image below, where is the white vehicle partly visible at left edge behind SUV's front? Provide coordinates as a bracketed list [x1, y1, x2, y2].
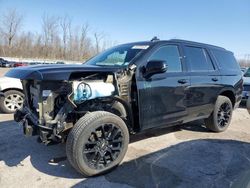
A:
[0, 77, 23, 113]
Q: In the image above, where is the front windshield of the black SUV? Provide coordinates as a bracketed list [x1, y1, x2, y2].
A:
[86, 44, 149, 66]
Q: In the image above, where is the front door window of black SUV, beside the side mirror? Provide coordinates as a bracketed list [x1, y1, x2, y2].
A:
[149, 45, 182, 72]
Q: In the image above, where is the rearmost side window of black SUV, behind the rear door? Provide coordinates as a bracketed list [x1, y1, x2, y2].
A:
[211, 50, 240, 70]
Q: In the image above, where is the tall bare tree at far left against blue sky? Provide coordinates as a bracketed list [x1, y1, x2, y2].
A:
[0, 9, 23, 48]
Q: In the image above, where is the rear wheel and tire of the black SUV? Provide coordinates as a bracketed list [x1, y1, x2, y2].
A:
[205, 95, 233, 132]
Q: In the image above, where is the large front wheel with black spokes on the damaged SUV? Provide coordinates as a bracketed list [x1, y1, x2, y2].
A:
[66, 111, 129, 177]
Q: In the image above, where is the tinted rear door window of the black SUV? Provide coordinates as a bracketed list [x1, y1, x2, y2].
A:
[184, 46, 214, 71]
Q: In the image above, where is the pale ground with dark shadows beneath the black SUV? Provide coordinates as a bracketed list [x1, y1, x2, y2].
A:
[0, 69, 250, 188]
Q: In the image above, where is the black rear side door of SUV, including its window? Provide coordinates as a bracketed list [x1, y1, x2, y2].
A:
[183, 45, 221, 120]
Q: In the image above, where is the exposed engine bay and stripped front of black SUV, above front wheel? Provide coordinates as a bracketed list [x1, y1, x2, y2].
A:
[14, 70, 136, 144]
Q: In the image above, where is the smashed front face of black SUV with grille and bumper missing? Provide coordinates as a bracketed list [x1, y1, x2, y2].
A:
[14, 80, 75, 143]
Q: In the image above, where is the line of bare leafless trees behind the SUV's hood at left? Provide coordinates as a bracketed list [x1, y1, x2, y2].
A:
[0, 10, 115, 60]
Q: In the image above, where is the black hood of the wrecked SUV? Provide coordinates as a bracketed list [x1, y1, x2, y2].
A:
[5, 64, 119, 80]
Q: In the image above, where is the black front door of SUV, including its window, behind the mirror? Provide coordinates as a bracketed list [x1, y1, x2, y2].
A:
[137, 44, 190, 129]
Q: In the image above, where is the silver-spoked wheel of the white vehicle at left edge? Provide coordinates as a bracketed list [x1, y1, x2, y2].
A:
[0, 90, 24, 114]
